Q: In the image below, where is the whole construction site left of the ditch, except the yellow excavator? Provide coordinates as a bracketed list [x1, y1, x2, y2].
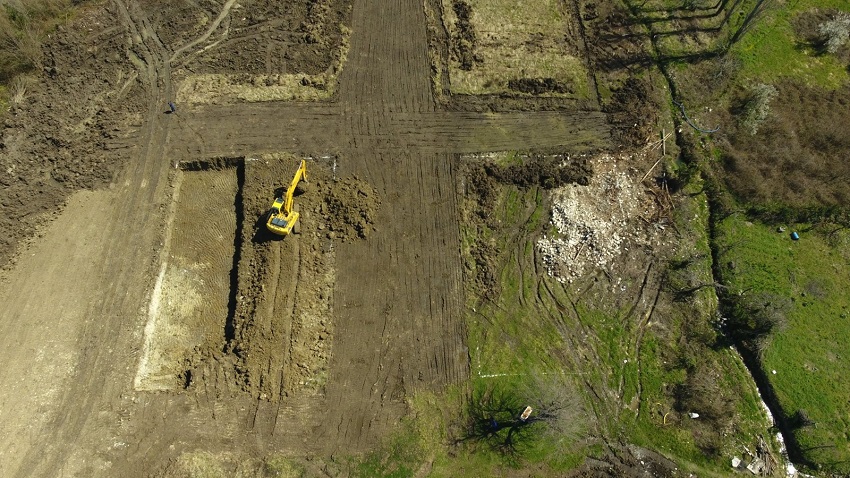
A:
[0, 0, 816, 478]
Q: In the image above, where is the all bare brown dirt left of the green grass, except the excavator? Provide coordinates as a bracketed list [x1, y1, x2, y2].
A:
[0, 0, 609, 476]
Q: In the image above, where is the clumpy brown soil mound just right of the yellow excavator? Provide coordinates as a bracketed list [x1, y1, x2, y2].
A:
[319, 176, 381, 242]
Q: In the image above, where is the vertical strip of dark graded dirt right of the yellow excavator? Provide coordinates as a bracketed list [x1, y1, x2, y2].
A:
[300, 0, 468, 450]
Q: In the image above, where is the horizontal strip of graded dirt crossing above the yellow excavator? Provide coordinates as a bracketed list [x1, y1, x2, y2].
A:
[174, 107, 610, 156]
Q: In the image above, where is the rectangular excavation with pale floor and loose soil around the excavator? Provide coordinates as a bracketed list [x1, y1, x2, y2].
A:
[135, 154, 379, 400]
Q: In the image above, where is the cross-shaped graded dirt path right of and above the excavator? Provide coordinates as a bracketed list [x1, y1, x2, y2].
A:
[170, 0, 609, 450]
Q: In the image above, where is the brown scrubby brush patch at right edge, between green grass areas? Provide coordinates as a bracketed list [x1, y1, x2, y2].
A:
[717, 82, 850, 207]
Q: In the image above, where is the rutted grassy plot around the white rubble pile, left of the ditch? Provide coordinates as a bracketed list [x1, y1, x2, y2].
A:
[446, 154, 771, 476]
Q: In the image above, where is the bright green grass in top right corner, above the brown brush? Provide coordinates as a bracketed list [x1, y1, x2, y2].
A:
[732, 0, 848, 89]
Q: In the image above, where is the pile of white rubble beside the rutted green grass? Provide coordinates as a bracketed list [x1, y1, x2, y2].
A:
[537, 155, 653, 282]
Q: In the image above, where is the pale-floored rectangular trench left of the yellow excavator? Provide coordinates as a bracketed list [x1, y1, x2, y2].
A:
[135, 158, 244, 391]
